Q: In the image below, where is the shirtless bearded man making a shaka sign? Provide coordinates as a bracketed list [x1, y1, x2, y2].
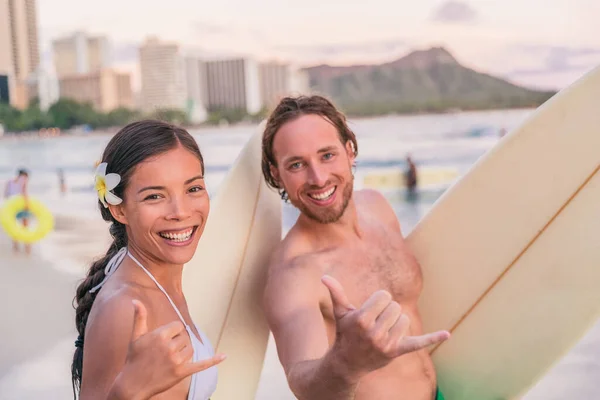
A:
[262, 96, 449, 400]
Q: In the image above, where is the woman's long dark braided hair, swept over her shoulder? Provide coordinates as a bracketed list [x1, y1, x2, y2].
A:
[71, 120, 204, 398]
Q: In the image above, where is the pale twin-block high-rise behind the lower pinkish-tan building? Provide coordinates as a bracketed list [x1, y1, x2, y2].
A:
[52, 32, 110, 78]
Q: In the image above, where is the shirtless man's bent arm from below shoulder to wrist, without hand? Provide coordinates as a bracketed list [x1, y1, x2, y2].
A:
[264, 265, 358, 400]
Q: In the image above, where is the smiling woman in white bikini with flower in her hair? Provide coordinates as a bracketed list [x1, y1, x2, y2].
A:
[72, 120, 224, 400]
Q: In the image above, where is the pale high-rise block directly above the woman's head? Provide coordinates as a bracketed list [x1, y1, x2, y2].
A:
[140, 37, 187, 112]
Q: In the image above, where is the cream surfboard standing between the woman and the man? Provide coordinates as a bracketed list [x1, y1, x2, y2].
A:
[183, 124, 281, 400]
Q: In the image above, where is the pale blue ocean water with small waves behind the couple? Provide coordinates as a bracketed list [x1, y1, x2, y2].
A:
[0, 110, 532, 234]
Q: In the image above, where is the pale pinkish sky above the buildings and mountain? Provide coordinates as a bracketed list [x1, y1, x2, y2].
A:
[38, 0, 600, 89]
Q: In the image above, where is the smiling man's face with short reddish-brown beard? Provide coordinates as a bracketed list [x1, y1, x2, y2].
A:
[271, 114, 354, 224]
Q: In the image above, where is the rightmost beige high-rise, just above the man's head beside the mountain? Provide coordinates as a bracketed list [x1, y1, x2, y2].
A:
[259, 62, 308, 108]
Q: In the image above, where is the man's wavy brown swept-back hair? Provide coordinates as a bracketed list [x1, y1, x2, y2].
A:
[261, 95, 358, 200]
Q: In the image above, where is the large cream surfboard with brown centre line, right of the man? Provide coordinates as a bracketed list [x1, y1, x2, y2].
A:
[407, 69, 600, 400]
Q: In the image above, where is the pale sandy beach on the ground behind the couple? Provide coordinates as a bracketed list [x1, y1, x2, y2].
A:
[0, 202, 600, 400]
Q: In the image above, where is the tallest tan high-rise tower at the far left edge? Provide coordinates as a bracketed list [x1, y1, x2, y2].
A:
[0, 0, 40, 108]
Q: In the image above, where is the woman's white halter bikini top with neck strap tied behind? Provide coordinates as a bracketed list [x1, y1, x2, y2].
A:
[90, 247, 217, 400]
